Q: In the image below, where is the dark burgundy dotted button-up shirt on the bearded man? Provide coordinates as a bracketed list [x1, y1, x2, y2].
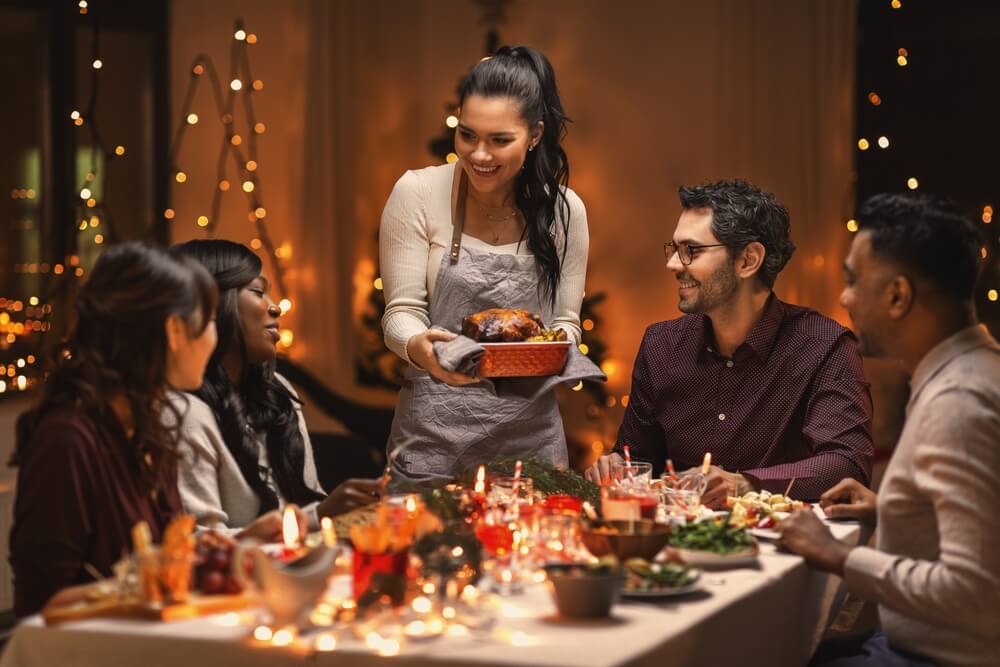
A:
[615, 294, 874, 500]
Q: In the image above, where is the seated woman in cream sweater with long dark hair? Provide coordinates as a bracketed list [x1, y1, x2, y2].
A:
[168, 239, 378, 538]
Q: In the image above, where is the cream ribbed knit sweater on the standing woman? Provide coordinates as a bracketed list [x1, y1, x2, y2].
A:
[379, 164, 590, 361]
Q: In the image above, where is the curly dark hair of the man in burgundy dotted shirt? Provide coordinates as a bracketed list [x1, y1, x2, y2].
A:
[677, 180, 795, 288]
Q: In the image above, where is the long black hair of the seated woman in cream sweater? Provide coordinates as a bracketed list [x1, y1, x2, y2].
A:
[171, 239, 323, 514]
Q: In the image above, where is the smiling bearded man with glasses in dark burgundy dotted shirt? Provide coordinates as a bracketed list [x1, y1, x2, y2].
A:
[586, 181, 874, 508]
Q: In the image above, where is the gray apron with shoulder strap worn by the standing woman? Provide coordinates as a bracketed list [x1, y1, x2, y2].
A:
[387, 170, 569, 487]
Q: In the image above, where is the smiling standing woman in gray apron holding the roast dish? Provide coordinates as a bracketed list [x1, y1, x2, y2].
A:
[379, 46, 589, 482]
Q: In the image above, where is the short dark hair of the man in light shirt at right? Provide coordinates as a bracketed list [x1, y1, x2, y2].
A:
[858, 194, 983, 301]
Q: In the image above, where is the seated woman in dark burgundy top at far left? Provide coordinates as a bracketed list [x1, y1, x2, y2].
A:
[10, 243, 216, 616]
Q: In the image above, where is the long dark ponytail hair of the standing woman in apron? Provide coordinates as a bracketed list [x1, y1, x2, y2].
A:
[459, 46, 570, 304]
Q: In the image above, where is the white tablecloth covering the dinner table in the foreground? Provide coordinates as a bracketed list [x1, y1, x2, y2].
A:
[0, 524, 859, 667]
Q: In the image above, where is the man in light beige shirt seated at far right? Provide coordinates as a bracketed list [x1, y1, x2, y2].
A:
[779, 195, 1000, 667]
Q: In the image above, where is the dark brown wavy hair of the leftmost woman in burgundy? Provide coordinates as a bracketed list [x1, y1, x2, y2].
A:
[11, 242, 216, 491]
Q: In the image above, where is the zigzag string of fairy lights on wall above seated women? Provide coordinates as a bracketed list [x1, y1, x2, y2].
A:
[163, 19, 295, 350]
